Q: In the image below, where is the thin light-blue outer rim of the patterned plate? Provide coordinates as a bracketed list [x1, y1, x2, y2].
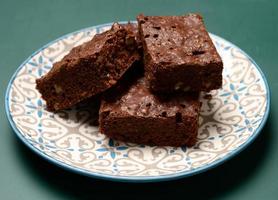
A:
[5, 21, 270, 182]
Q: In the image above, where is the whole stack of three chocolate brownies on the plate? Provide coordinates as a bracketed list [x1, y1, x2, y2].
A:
[37, 14, 223, 146]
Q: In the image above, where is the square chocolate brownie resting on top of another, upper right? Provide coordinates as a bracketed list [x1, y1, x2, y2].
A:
[137, 14, 223, 93]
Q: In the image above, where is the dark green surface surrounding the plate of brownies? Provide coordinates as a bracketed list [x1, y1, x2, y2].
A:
[0, 0, 278, 199]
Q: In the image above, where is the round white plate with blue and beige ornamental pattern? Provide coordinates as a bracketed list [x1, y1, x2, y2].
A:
[6, 21, 270, 182]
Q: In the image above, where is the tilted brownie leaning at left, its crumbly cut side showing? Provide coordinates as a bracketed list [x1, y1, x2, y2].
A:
[36, 23, 140, 111]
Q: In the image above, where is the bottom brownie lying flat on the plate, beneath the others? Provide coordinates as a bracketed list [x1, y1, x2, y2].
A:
[99, 73, 200, 146]
